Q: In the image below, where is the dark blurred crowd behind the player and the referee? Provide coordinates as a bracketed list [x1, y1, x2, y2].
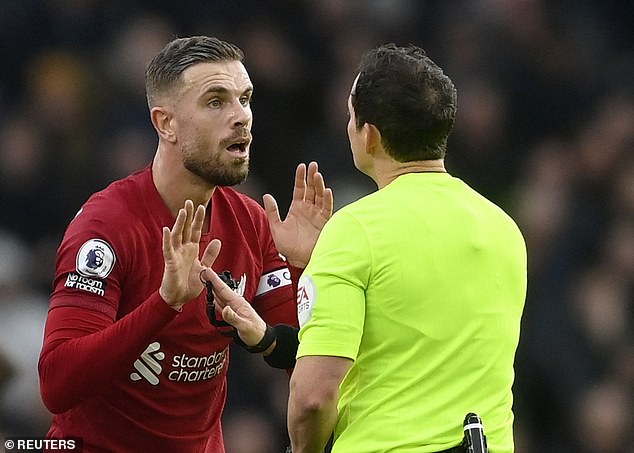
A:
[0, 0, 634, 453]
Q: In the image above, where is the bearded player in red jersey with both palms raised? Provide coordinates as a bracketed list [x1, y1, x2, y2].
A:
[39, 36, 332, 453]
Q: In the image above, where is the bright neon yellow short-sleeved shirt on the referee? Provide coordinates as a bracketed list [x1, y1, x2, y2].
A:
[297, 173, 526, 453]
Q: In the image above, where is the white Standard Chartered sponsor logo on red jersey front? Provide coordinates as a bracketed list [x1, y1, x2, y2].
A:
[130, 341, 228, 385]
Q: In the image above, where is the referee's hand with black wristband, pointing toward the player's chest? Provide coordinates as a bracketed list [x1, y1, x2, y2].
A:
[201, 268, 266, 346]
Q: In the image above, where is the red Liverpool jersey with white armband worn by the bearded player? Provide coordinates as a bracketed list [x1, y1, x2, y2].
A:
[40, 167, 297, 453]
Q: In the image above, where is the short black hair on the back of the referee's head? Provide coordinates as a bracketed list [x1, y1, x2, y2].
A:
[351, 44, 457, 162]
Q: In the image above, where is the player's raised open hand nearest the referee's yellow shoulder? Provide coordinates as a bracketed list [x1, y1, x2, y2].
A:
[264, 162, 333, 268]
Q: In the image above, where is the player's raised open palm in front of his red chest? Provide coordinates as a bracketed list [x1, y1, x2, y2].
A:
[159, 200, 220, 310]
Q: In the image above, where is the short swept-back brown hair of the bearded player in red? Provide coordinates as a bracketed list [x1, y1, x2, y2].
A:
[145, 36, 244, 108]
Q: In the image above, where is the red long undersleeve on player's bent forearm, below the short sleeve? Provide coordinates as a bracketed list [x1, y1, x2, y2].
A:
[39, 292, 178, 413]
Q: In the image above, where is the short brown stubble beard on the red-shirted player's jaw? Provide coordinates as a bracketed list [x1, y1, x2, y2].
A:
[182, 136, 249, 186]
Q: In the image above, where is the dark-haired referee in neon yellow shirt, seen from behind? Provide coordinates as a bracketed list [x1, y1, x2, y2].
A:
[206, 45, 527, 453]
